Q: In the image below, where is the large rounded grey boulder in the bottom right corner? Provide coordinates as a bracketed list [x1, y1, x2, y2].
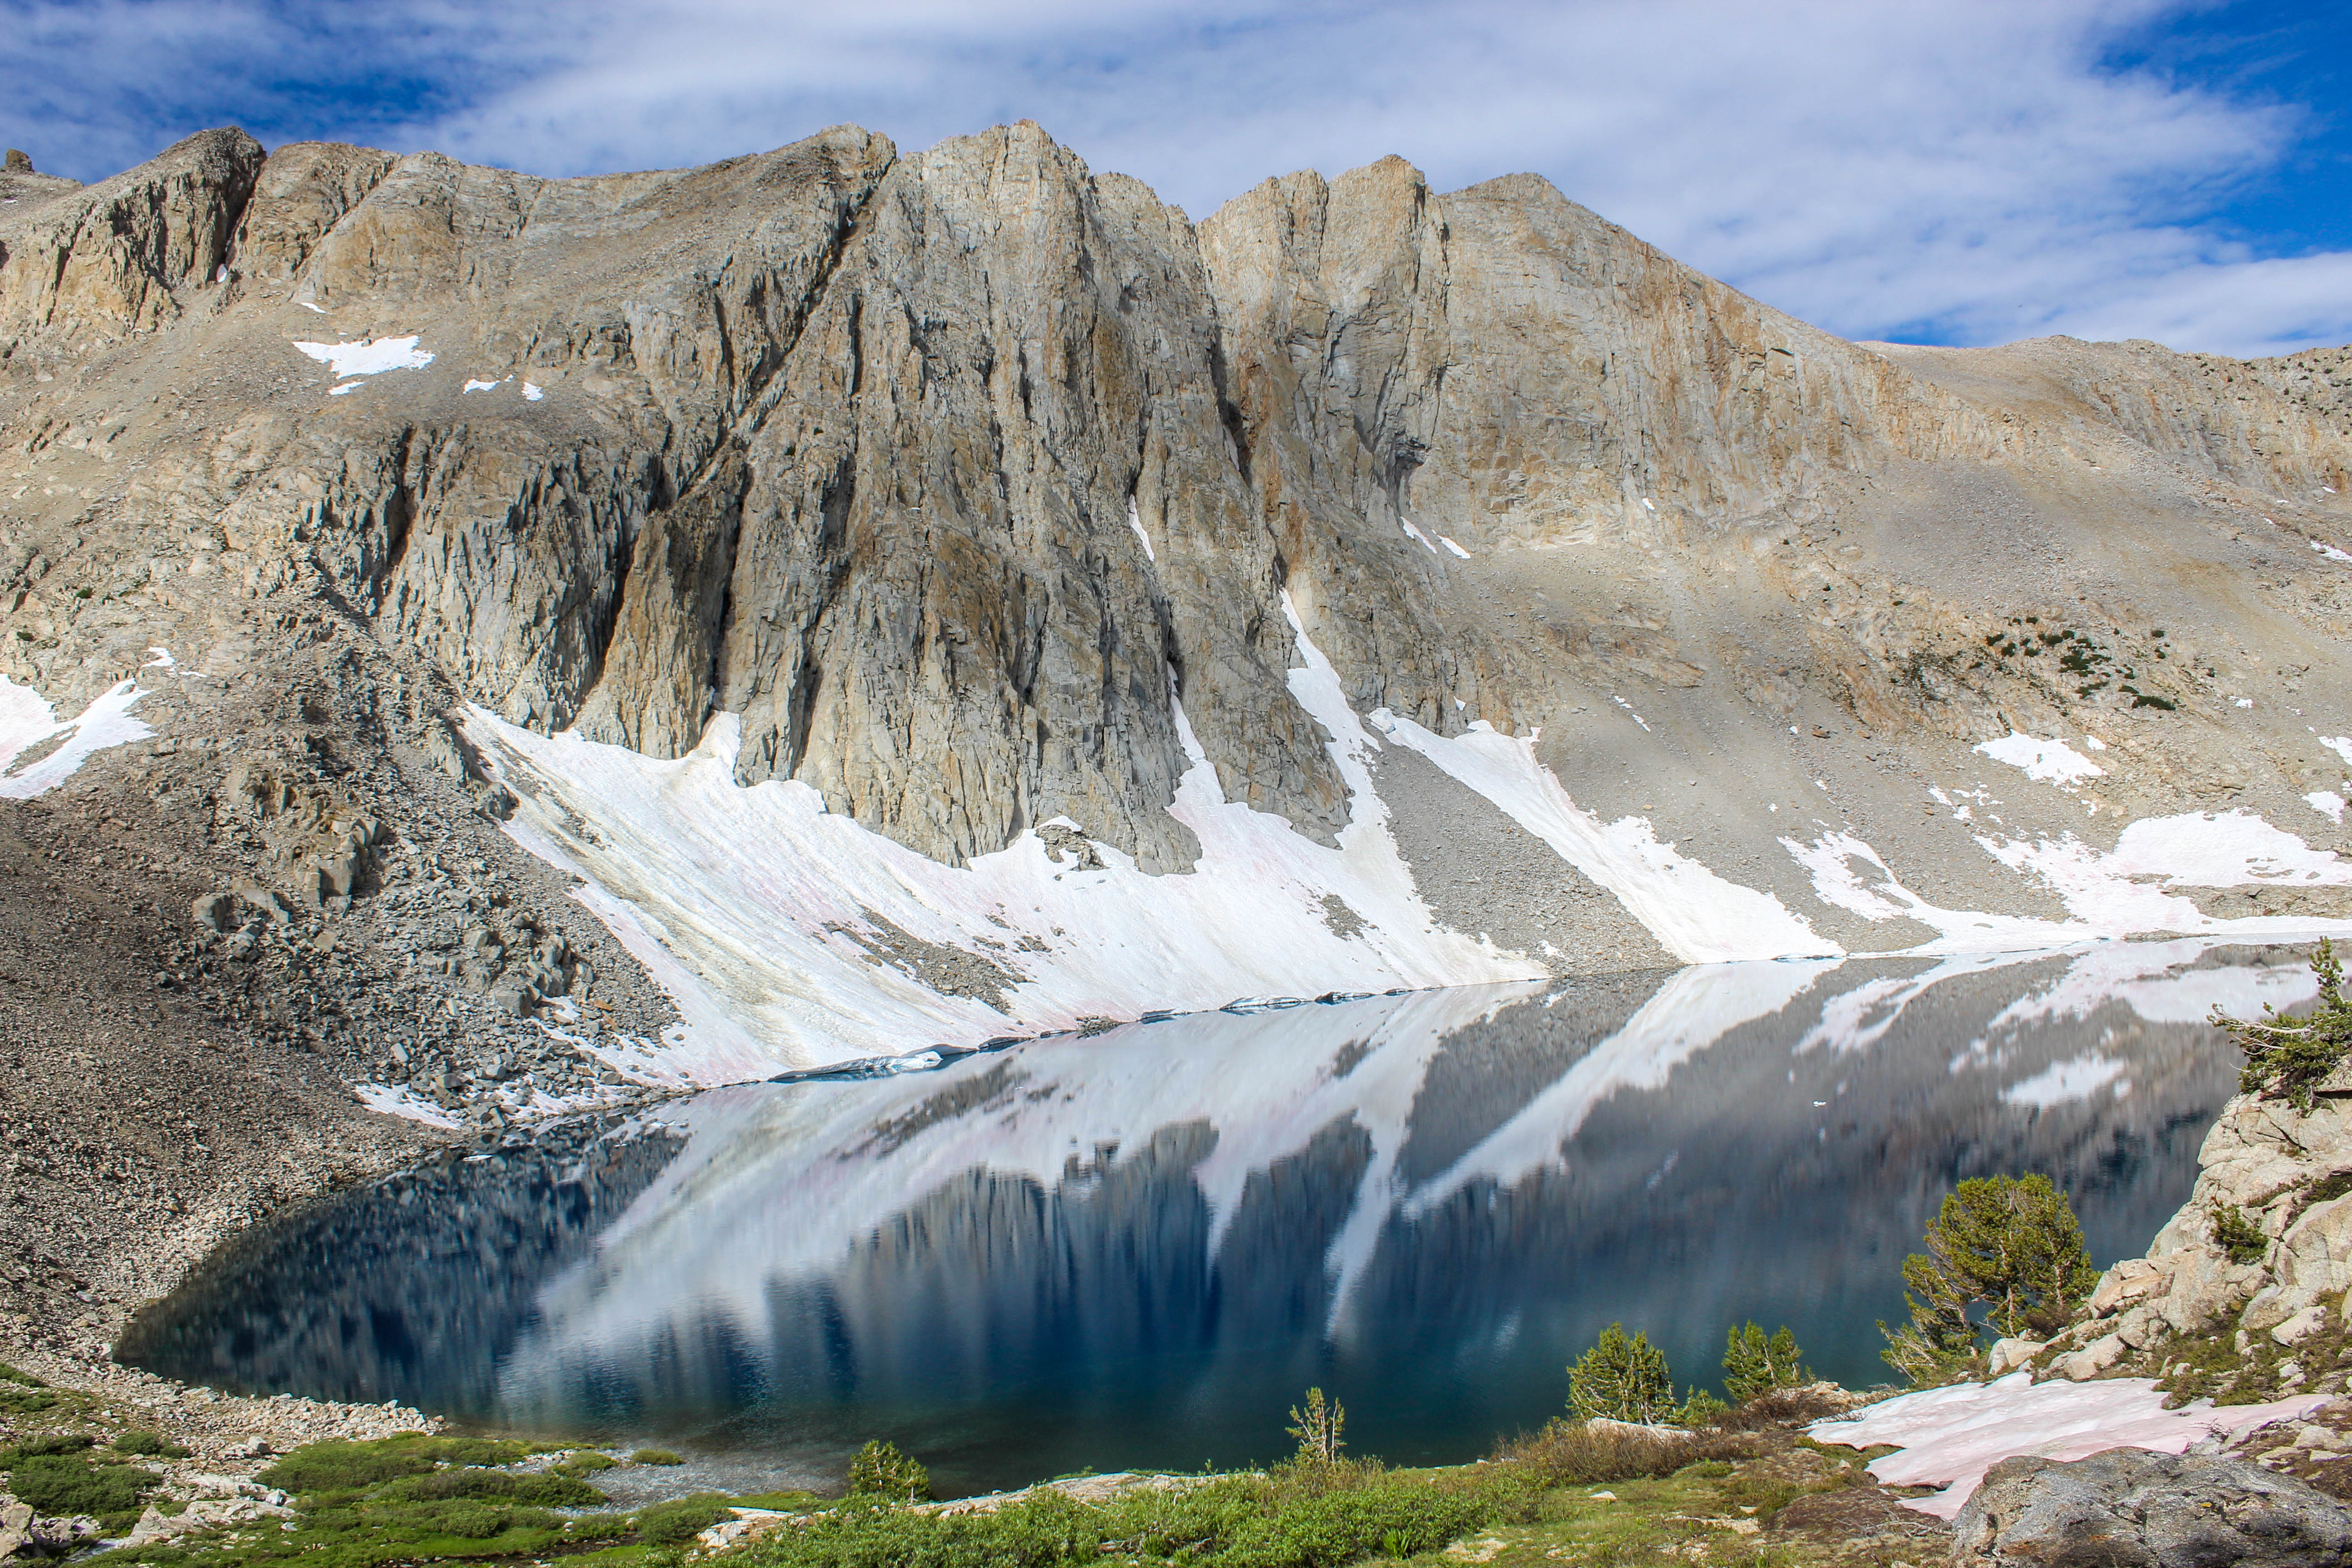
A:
[1952, 1448, 2352, 1568]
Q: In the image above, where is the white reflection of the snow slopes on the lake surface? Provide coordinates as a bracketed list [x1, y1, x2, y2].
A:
[487, 943, 2310, 1408]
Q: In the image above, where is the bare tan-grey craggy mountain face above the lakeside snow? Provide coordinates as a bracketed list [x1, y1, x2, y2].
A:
[14, 125, 2352, 964]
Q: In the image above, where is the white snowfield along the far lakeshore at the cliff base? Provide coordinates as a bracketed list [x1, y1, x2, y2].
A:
[466, 595, 2352, 1093]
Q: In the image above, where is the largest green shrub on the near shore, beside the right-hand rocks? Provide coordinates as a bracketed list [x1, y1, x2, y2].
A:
[1879, 1176, 2098, 1382]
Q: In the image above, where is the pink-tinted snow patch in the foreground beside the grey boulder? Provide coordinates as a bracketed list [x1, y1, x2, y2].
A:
[1806, 1373, 2328, 1519]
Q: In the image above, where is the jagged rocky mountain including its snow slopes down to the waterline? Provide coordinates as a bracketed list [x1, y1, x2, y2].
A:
[14, 122, 2352, 1077]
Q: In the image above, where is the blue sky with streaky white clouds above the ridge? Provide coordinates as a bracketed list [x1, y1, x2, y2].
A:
[0, 0, 2352, 355]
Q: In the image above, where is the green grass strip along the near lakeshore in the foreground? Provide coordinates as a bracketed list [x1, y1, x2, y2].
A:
[59, 1399, 1910, 1568]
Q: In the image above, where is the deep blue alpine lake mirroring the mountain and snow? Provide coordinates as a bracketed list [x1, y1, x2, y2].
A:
[118, 943, 2312, 1495]
